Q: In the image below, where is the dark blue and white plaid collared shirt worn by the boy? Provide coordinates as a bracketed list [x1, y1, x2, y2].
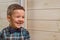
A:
[0, 27, 30, 40]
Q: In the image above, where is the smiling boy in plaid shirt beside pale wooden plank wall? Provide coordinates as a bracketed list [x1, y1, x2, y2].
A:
[0, 4, 30, 40]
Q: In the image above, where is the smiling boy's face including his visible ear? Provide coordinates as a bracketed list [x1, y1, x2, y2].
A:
[7, 9, 25, 28]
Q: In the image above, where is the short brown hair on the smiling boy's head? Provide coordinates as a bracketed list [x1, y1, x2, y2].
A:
[7, 4, 25, 16]
